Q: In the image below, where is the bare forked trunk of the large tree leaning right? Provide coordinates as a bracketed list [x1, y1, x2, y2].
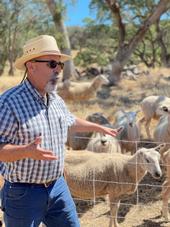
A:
[105, 0, 170, 85]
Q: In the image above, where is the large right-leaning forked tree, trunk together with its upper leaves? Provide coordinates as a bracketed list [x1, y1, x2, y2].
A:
[91, 0, 170, 85]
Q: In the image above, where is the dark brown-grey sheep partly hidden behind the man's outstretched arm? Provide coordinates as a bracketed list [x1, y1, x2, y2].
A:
[67, 112, 112, 150]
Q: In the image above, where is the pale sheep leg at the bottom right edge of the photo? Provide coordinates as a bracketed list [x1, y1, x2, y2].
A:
[162, 180, 170, 221]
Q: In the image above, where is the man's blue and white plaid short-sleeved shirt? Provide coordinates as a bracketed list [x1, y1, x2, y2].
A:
[0, 80, 75, 183]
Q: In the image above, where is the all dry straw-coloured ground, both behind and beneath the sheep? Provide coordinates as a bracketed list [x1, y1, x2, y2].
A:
[0, 66, 170, 227]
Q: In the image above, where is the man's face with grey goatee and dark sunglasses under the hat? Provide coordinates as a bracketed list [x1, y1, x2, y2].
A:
[27, 55, 62, 95]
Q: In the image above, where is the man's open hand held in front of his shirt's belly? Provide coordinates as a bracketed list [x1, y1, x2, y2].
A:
[25, 137, 58, 160]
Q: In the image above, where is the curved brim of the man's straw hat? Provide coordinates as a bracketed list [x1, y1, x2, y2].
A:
[15, 51, 71, 70]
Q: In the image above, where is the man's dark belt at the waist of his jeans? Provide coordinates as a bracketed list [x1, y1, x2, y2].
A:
[5, 180, 56, 188]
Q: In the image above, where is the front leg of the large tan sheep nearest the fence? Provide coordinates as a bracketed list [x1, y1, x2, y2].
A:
[109, 194, 120, 227]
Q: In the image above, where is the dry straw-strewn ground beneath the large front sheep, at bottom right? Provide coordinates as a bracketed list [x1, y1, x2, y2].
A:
[76, 175, 170, 227]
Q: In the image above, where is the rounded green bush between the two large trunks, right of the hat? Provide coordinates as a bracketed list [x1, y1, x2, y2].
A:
[69, 20, 117, 67]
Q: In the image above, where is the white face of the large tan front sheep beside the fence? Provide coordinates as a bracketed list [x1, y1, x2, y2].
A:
[138, 144, 164, 179]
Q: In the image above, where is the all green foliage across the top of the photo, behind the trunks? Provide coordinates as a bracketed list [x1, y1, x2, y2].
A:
[0, 0, 170, 71]
